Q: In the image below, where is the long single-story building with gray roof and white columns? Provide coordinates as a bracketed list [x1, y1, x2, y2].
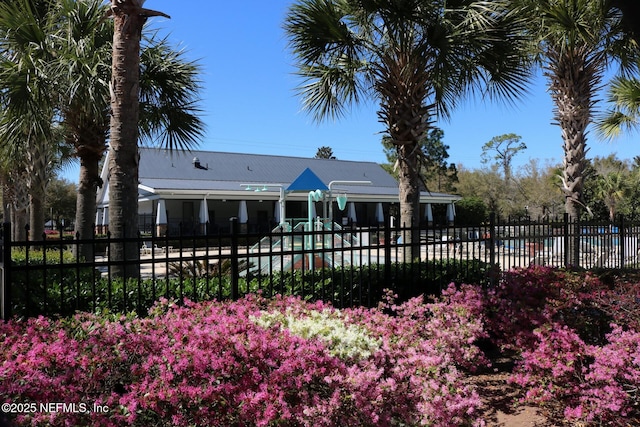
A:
[96, 148, 460, 235]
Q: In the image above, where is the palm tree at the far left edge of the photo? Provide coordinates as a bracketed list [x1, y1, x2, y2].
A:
[0, 0, 57, 239]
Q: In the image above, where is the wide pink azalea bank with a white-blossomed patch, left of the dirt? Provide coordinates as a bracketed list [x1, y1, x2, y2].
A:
[0, 290, 482, 427]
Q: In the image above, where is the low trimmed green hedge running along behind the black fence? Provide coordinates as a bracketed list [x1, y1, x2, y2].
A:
[7, 256, 492, 316]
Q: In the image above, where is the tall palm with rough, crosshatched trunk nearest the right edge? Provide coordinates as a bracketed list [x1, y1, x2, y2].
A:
[518, 0, 634, 264]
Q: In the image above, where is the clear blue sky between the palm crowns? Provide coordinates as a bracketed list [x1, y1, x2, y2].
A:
[65, 0, 640, 181]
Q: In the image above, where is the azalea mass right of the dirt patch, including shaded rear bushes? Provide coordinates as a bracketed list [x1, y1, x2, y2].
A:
[496, 267, 640, 426]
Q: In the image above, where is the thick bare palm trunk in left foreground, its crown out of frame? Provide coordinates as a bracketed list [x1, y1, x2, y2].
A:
[108, 0, 146, 277]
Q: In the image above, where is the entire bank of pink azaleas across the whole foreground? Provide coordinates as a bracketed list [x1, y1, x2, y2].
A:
[0, 267, 640, 427]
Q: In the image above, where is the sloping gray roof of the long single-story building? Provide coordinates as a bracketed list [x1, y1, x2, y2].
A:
[99, 148, 459, 201]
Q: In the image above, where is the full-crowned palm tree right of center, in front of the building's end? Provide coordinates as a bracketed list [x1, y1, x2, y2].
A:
[284, 0, 528, 256]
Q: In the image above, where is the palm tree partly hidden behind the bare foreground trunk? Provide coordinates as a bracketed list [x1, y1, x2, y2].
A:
[58, 0, 203, 258]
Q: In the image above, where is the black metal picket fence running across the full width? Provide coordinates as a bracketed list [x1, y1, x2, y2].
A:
[0, 216, 640, 319]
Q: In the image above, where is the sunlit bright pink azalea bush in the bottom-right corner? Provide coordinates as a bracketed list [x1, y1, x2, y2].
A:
[511, 324, 640, 426]
